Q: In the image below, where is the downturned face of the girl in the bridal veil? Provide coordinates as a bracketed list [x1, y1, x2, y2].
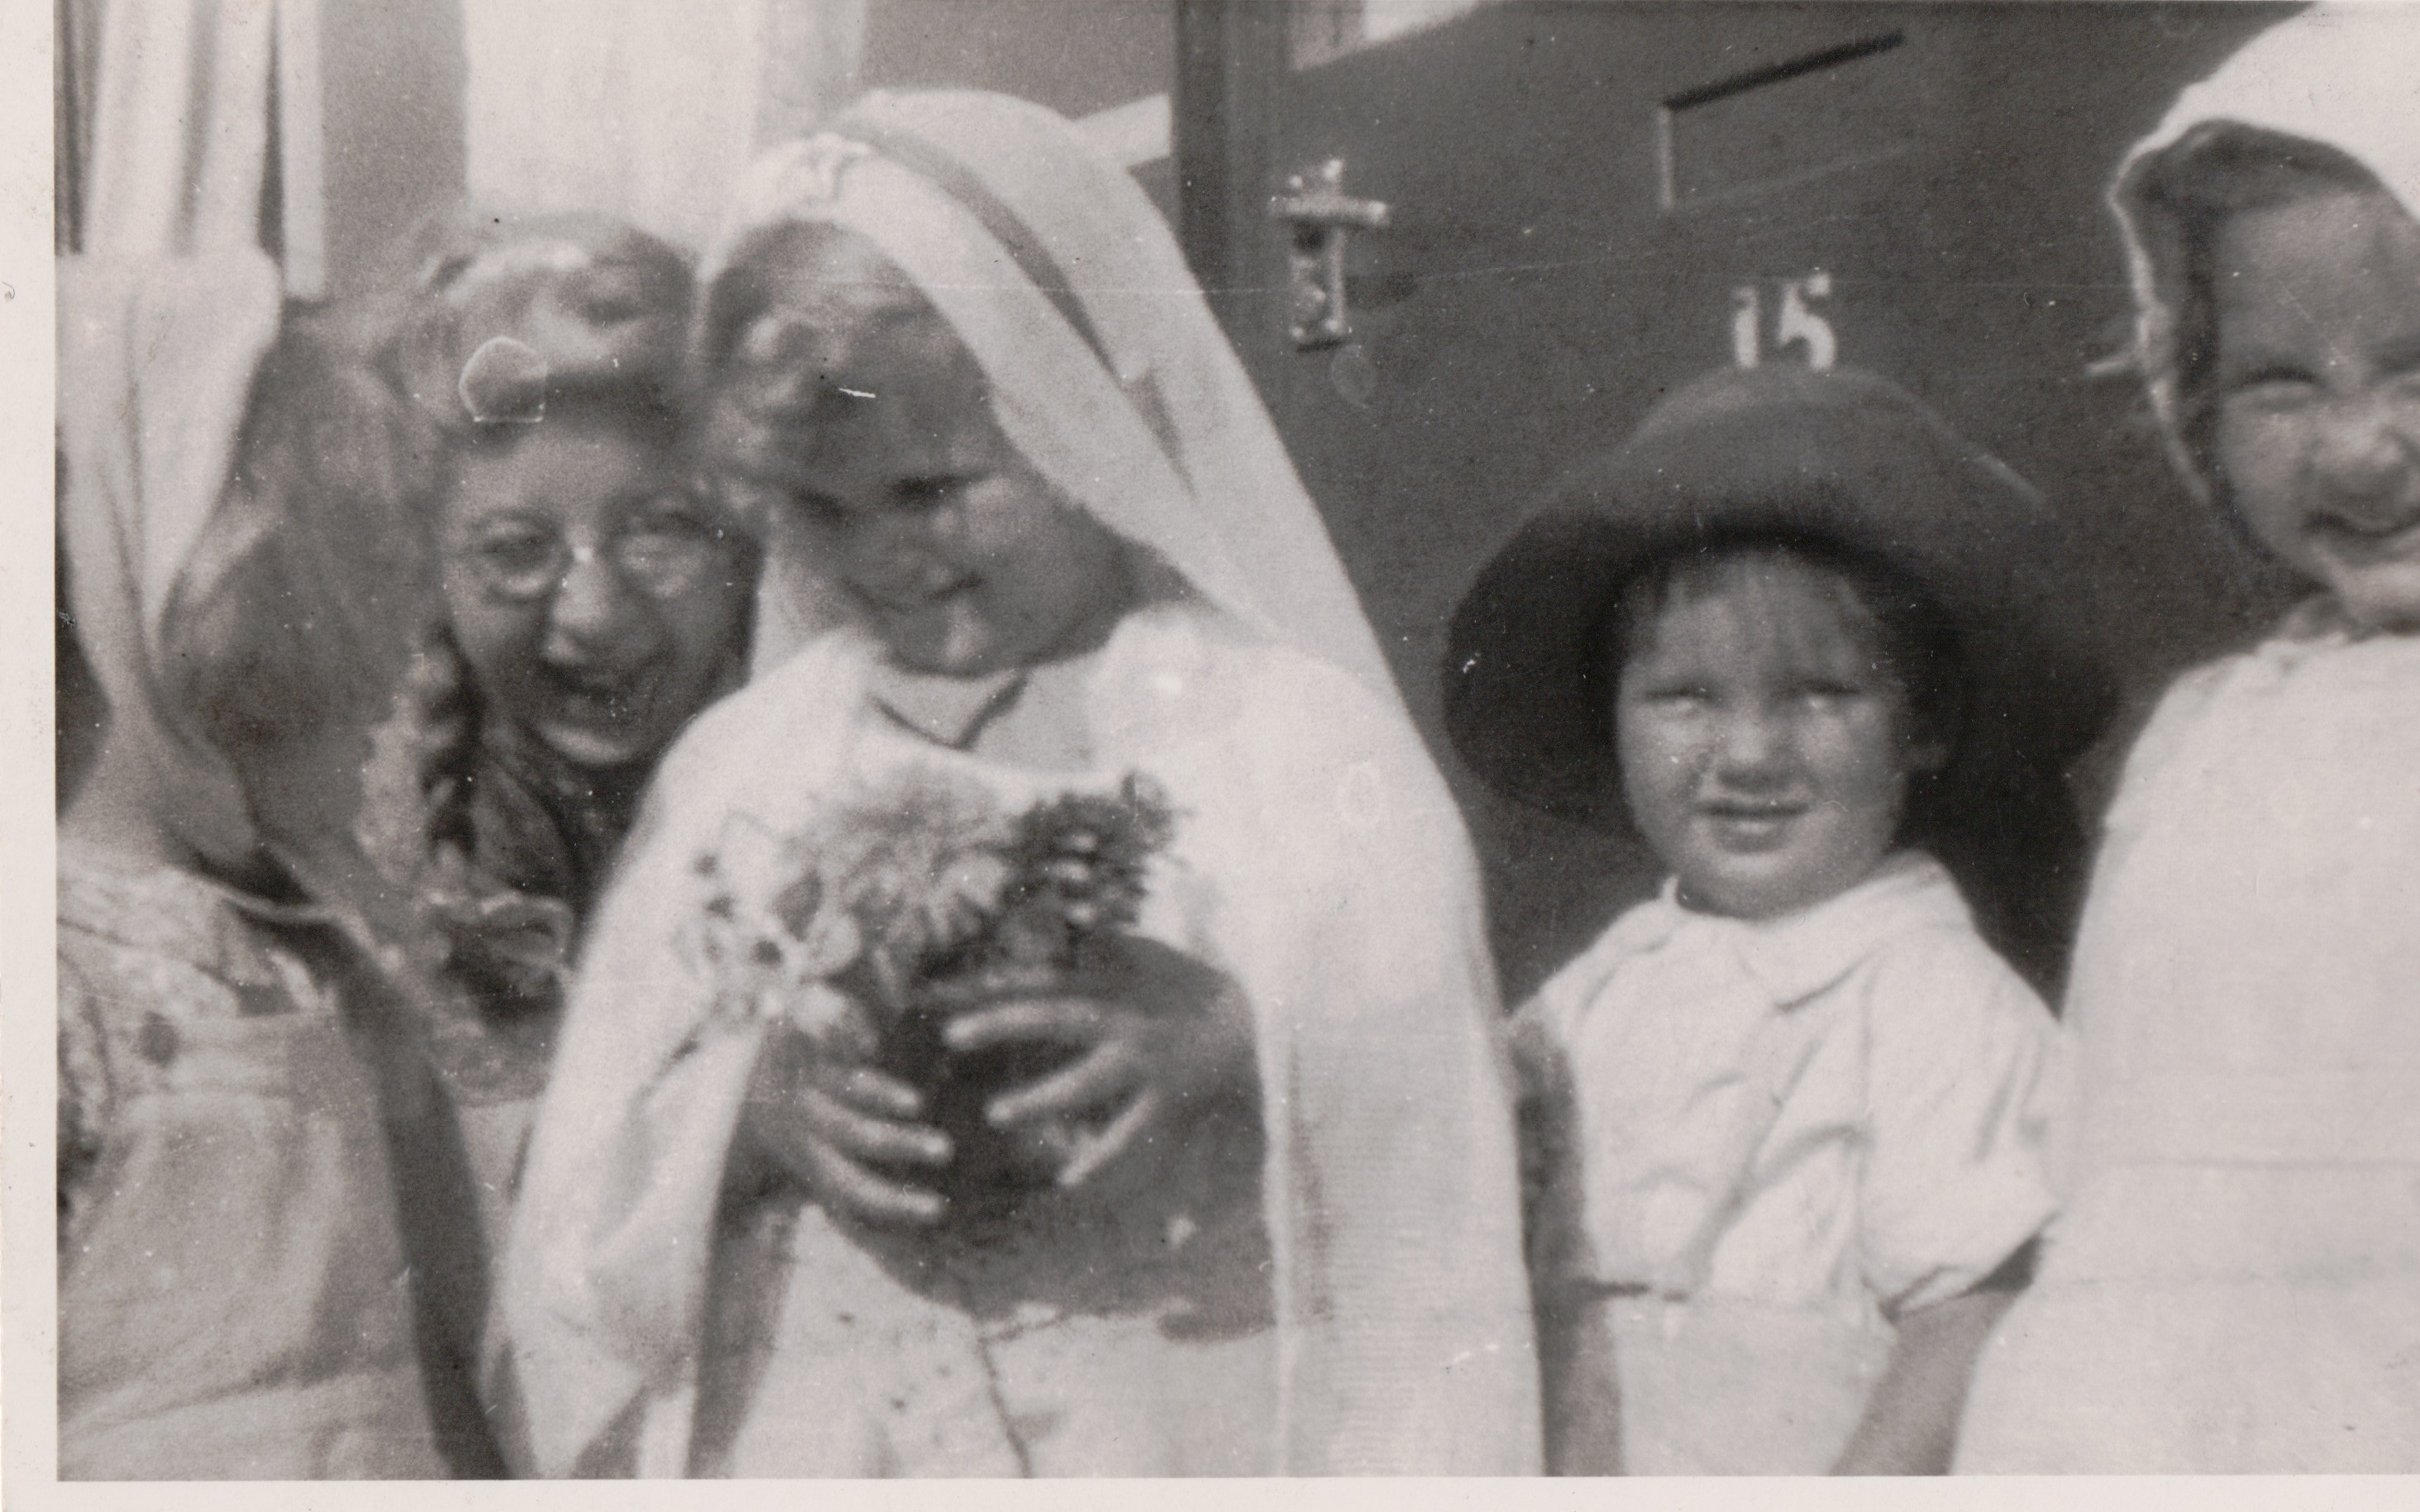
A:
[755, 312, 1133, 677]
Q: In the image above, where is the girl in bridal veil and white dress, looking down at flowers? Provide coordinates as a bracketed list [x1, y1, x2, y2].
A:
[491, 92, 1539, 1476]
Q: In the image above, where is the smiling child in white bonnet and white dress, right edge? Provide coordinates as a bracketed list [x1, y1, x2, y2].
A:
[1958, 7, 2420, 1473]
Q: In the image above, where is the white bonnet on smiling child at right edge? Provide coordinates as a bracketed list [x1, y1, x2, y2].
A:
[2110, 5, 2420, 503]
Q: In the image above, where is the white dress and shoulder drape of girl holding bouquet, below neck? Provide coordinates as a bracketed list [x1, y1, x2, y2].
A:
[506, 594, 1537, 1476]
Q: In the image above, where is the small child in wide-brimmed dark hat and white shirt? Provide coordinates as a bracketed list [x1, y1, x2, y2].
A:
[1444, 368, 2107, 1473]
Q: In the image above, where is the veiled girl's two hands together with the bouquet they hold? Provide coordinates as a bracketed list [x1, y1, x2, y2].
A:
[685, 770, 1229, 1224]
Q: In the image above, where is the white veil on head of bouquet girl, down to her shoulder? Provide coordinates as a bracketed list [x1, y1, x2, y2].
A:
[699, 89, 1394, 699]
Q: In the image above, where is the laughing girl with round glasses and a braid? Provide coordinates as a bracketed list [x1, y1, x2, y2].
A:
[365, 213, 755, 1241]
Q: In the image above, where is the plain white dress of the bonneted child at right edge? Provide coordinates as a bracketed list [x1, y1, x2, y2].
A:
[1958, 614, 2420, 1473]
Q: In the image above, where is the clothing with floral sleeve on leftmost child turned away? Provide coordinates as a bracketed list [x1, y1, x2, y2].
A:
[58, 842, 496, 1481]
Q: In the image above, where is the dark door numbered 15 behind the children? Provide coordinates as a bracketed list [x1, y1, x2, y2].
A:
[1177, 0, 2279, 997]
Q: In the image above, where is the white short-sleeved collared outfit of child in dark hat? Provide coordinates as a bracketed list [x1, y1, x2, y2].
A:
[1517, 854, 2057, 1476]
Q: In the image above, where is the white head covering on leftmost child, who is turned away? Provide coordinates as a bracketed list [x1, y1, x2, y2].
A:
[58, 249, 281, 861]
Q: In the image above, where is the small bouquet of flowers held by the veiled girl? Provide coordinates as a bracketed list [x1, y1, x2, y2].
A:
[682, 767, 1177, 1212]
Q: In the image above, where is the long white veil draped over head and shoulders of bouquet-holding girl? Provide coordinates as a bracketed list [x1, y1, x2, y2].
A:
[491, 92, 1539, 1473]
